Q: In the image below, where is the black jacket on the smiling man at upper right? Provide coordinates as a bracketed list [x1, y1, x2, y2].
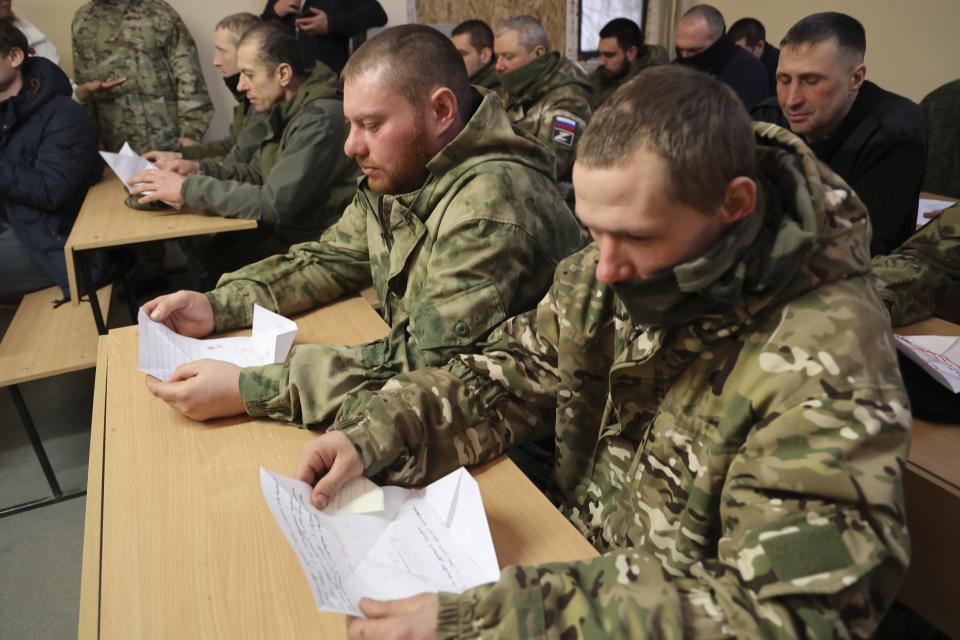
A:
[751, 81, 927, 255]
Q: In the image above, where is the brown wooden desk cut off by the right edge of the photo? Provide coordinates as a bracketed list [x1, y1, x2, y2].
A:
[897, 318, 960, 637]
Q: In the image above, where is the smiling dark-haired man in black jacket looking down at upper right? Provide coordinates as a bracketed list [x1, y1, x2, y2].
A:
[752, 12, 927, 255]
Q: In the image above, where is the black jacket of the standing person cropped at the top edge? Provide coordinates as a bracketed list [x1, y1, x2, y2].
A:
[260, 0, 387, 75]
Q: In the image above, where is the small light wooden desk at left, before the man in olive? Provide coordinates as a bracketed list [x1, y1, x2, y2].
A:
[63, 173, 257, 304]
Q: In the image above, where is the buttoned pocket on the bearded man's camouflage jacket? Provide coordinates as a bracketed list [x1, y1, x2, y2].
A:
[410, 282, 507, 349]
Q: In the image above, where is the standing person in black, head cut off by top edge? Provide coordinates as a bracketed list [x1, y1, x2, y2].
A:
[260, 0, 387, 75]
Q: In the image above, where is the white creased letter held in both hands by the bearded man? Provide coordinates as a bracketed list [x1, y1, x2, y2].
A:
[137, 305, 297, 380]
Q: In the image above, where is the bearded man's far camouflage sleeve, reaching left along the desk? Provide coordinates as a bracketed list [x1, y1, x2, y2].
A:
[207, 196, 372, 331]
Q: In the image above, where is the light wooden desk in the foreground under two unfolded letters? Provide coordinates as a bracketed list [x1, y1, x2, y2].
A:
[79, 298, 596, 639]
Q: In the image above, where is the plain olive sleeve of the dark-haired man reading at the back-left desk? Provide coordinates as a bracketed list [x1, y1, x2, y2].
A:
[181, 109, 346, 228]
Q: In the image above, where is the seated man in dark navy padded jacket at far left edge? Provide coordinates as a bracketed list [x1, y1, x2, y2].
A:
[0, 20, 103, 300]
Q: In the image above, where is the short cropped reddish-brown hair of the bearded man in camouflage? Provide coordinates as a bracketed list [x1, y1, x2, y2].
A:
[340, 24, 472, 121]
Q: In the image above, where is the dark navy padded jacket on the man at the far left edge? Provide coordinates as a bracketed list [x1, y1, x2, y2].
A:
[0, 58, 103, 295]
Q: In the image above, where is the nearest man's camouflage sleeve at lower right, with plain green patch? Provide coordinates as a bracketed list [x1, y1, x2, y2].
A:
[438, 382, 910, 639]
